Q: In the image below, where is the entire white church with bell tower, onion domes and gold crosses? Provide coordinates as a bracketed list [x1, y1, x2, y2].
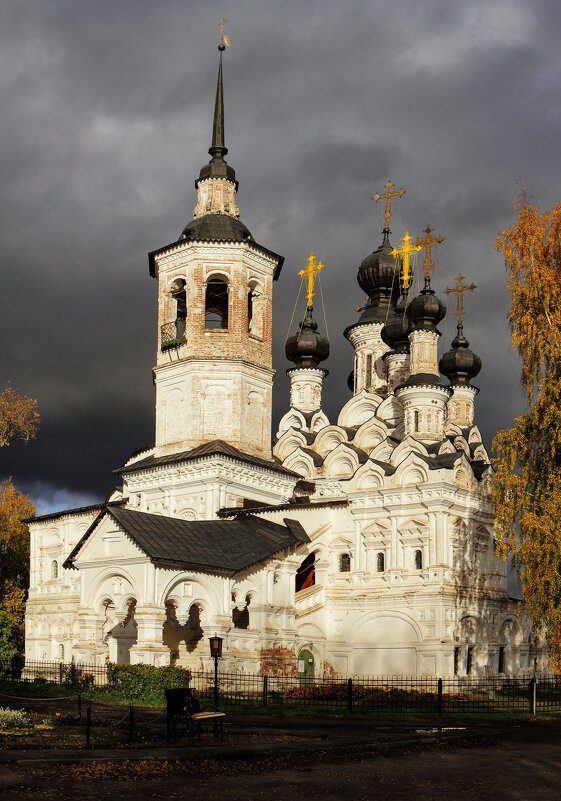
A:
[25, 44, 545, 676]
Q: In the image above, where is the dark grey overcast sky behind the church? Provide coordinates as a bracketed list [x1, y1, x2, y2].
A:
[0, 0, 561, 512]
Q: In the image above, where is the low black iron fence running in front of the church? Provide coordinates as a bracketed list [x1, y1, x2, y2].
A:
[18, 661, 561, 715]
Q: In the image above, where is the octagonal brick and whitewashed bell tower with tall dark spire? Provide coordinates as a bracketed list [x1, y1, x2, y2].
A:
[149, 41, 283, 459]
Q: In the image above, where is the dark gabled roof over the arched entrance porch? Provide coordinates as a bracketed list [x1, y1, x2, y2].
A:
[65, 507, 310, 573]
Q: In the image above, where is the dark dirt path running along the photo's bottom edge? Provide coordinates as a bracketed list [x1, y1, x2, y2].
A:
[4, 729, 561, 801]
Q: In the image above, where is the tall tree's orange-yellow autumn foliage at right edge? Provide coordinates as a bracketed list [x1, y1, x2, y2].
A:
[493, 192, 561, 672]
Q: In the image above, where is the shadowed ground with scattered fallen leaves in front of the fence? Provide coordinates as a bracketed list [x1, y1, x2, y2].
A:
[0, 719, 561, 801]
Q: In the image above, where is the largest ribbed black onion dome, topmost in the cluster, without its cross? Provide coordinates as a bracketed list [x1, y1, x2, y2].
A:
[345, 228, 399, 333]
